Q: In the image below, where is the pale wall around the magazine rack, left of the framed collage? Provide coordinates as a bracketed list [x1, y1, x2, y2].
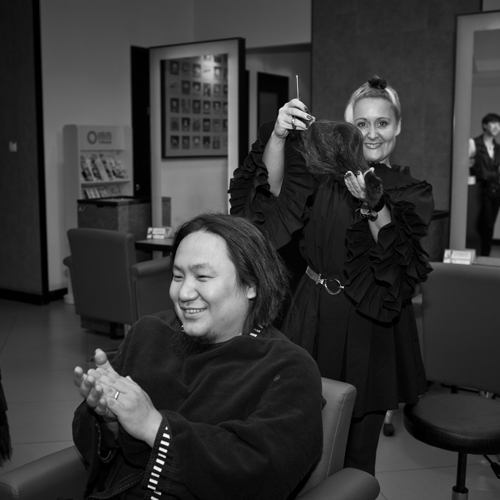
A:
[40, 0, 193, 290]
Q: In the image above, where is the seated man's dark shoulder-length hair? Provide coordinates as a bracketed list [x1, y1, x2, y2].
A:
[172, 213, 290, 335]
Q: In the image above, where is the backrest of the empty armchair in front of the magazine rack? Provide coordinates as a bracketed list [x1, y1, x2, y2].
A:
[68, 228, 138, 325]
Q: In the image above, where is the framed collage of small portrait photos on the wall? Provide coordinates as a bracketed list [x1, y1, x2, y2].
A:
[161, 54, 228, 158]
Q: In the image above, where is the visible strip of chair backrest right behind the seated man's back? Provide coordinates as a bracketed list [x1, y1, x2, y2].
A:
[299, 378, 356, 496]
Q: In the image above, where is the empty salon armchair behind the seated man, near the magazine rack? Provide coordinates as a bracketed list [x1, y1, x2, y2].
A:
[63, 228, 173, 336]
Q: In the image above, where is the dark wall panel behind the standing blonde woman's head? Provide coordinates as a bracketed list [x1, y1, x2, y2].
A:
[312, 0, 481, 210]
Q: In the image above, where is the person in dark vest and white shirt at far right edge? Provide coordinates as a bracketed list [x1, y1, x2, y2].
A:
[469, 113, 500, 256]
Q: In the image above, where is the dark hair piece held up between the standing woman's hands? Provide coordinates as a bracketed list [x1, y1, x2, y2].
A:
[298, 120, 368, 179]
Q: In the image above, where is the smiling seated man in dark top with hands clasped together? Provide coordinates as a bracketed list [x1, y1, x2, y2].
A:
[73, 215, 322, 500]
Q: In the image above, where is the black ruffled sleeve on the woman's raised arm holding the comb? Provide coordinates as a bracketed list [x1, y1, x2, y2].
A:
[229, 122, 316, 248]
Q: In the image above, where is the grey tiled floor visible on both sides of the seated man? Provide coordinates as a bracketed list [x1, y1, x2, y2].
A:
[0, 294, 500, 500]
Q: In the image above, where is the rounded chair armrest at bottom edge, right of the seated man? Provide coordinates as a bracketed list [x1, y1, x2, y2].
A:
[299, 468, 380, 500]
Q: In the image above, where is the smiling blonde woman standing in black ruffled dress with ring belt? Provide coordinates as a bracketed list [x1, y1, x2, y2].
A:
[229, 77, 433, 474]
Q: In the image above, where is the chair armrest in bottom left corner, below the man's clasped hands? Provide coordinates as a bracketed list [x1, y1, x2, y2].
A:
[0, 446, 87, 500]
